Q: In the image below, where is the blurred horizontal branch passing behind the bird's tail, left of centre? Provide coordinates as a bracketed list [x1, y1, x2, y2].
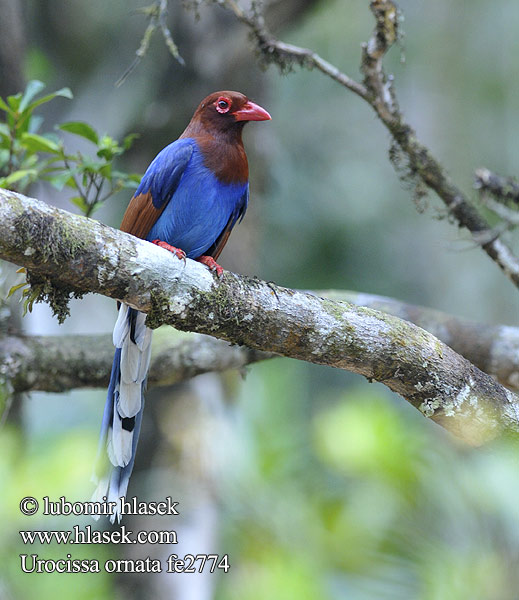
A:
[0, 327, 272, 392]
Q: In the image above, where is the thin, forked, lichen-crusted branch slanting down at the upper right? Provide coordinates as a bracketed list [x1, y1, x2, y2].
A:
[215, 0, 519, 287]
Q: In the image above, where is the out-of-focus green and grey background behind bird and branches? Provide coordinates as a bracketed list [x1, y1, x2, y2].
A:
[0, 0, 519, 600]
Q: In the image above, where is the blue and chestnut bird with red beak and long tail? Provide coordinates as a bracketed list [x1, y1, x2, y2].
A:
[93, 91, 271, 522]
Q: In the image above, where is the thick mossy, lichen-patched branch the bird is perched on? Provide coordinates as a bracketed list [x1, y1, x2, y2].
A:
[0, 190, 519, 443]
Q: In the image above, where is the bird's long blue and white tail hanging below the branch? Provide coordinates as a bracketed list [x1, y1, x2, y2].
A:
[92, 304, 152, 523]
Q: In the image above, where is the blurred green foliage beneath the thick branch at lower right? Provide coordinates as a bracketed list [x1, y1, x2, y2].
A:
[217, 361, 519, 600]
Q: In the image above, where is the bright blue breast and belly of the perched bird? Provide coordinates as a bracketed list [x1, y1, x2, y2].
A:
[146, 139, 248, 258]
